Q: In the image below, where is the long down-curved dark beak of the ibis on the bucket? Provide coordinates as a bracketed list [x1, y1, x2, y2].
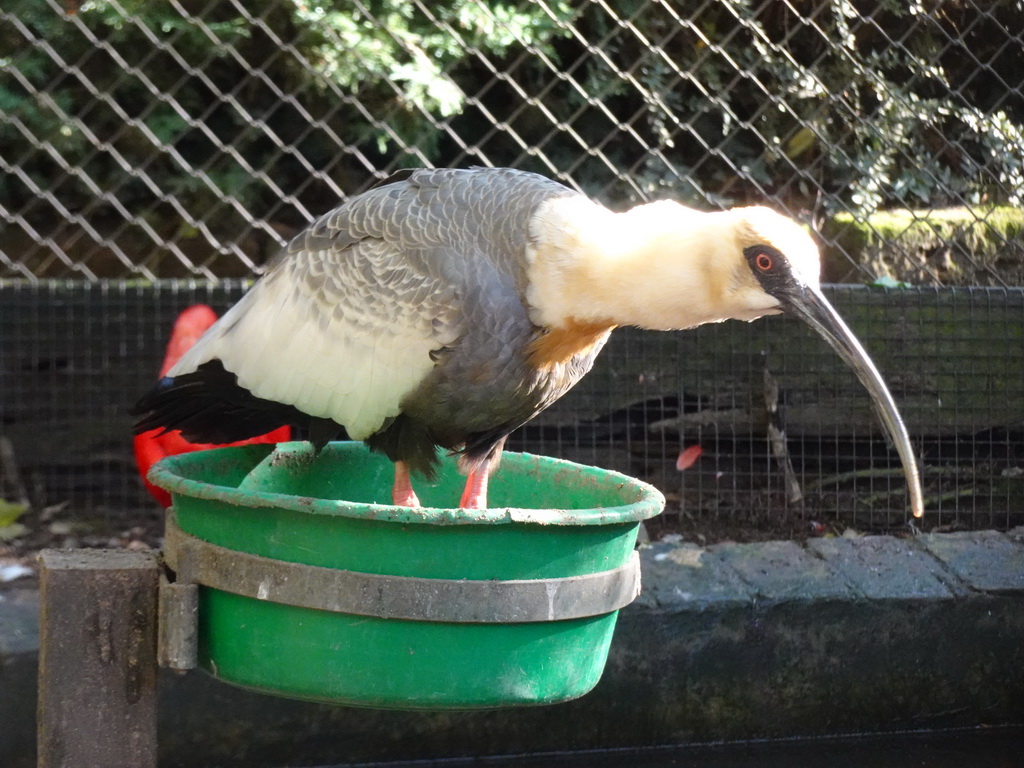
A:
[783, 286, 925, 517]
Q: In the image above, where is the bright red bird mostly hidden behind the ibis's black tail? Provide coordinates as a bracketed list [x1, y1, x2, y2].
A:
[132, 304, 292, 508]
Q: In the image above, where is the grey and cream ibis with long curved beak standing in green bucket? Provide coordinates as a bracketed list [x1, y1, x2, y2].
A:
[134, 168, 923, 516]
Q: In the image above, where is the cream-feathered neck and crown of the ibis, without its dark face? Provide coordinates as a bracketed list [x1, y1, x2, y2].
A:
[527, 197, 819, 331]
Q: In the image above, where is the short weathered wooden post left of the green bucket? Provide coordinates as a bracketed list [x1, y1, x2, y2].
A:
[38, 550, 160, 768]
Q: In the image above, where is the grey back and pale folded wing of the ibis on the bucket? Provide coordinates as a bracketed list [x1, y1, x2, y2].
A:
[171, 170, 574, 439]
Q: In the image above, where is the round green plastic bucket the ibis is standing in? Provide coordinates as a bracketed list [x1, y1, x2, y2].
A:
[150, 442, 665, 709]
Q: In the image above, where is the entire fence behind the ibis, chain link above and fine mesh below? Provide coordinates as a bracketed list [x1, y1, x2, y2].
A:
[0, 0, 1024, 529]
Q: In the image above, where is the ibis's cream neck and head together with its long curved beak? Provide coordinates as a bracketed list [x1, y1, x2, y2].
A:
[531, 199, 924, 517]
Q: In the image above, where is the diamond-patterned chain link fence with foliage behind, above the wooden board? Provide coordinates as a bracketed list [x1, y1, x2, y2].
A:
[0, 0, 1024, 285]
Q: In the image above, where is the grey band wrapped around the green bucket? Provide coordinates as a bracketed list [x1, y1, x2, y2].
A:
[164, 513, 640, 624]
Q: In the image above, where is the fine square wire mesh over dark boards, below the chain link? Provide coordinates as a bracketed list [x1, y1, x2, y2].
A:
[0, 281, 1024, 536]
